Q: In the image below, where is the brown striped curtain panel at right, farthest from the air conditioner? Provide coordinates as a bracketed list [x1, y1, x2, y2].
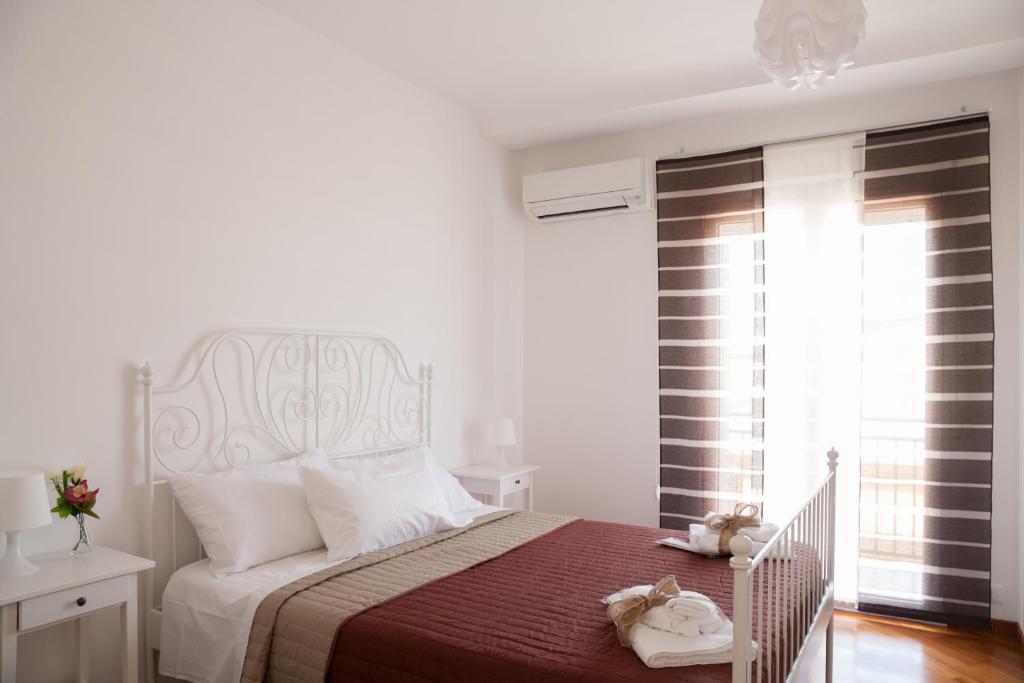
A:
[858, 117, 993, 626]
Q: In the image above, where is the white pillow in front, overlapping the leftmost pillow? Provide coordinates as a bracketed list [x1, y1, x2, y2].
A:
[299, 452, 459, 562]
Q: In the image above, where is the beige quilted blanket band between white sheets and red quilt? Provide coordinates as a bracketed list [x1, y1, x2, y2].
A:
[242, 510, 574, 683]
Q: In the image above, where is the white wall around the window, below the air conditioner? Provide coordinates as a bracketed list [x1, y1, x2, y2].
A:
[516, 72, 1024, 618]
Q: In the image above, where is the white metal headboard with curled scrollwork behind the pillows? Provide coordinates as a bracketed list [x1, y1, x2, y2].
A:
[141, 329, 433, 607]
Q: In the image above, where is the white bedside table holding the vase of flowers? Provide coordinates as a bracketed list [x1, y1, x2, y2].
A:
[0, 547, 155, 683]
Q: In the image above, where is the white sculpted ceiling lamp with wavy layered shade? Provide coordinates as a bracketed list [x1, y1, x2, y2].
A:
[754, 0, 867, 88]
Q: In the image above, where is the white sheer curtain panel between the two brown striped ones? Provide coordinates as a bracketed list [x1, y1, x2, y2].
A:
[764, 133, 864, 602]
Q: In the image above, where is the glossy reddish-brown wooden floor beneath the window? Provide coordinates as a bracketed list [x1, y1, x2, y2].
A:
[806, 611, 1024, 683]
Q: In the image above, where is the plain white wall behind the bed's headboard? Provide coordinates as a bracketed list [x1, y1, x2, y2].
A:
[0, 0, 522, 681]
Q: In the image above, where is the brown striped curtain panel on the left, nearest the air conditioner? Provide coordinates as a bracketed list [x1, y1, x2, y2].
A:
[656, 147, 765, 529]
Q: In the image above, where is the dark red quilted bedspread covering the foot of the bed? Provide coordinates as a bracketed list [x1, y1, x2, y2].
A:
[329, 521, 753, 683]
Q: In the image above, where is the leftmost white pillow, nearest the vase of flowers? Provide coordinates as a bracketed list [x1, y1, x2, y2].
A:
[170, 458, 324, 577]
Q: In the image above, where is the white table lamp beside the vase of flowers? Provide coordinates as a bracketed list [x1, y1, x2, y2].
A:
[0, 470, 53, 579]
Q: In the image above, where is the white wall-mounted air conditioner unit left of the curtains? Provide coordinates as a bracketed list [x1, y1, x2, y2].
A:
[522, 159, 653, 222]
